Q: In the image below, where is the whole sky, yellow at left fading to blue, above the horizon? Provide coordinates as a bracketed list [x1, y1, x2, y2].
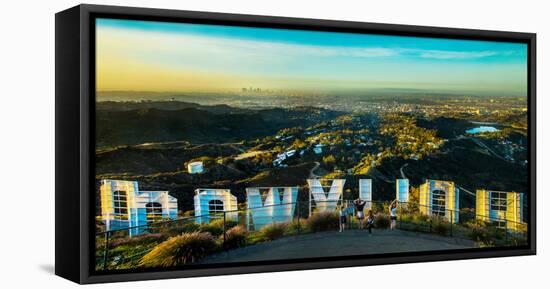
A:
[96, 18, 527, 96]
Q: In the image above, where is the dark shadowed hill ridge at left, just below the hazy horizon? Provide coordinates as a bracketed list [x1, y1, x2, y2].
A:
[96, 103, 338, 148]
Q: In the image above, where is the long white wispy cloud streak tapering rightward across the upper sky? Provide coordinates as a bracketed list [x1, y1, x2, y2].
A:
[98, 28, 513, 60]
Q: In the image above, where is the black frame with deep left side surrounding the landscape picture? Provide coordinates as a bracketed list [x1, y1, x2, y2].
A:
[55, 4, 536, 283]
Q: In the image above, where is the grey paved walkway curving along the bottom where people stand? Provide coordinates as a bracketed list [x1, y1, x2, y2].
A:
[203, 230, 474, 263]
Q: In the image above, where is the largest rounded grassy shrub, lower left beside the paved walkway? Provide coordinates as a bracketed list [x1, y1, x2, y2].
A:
[139, 232, 219, 267]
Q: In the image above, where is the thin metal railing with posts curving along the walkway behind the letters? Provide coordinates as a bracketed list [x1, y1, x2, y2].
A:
[95, 200, 527, 270]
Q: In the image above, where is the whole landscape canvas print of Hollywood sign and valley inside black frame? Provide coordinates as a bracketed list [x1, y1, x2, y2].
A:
[93, 18, 530, 272]
